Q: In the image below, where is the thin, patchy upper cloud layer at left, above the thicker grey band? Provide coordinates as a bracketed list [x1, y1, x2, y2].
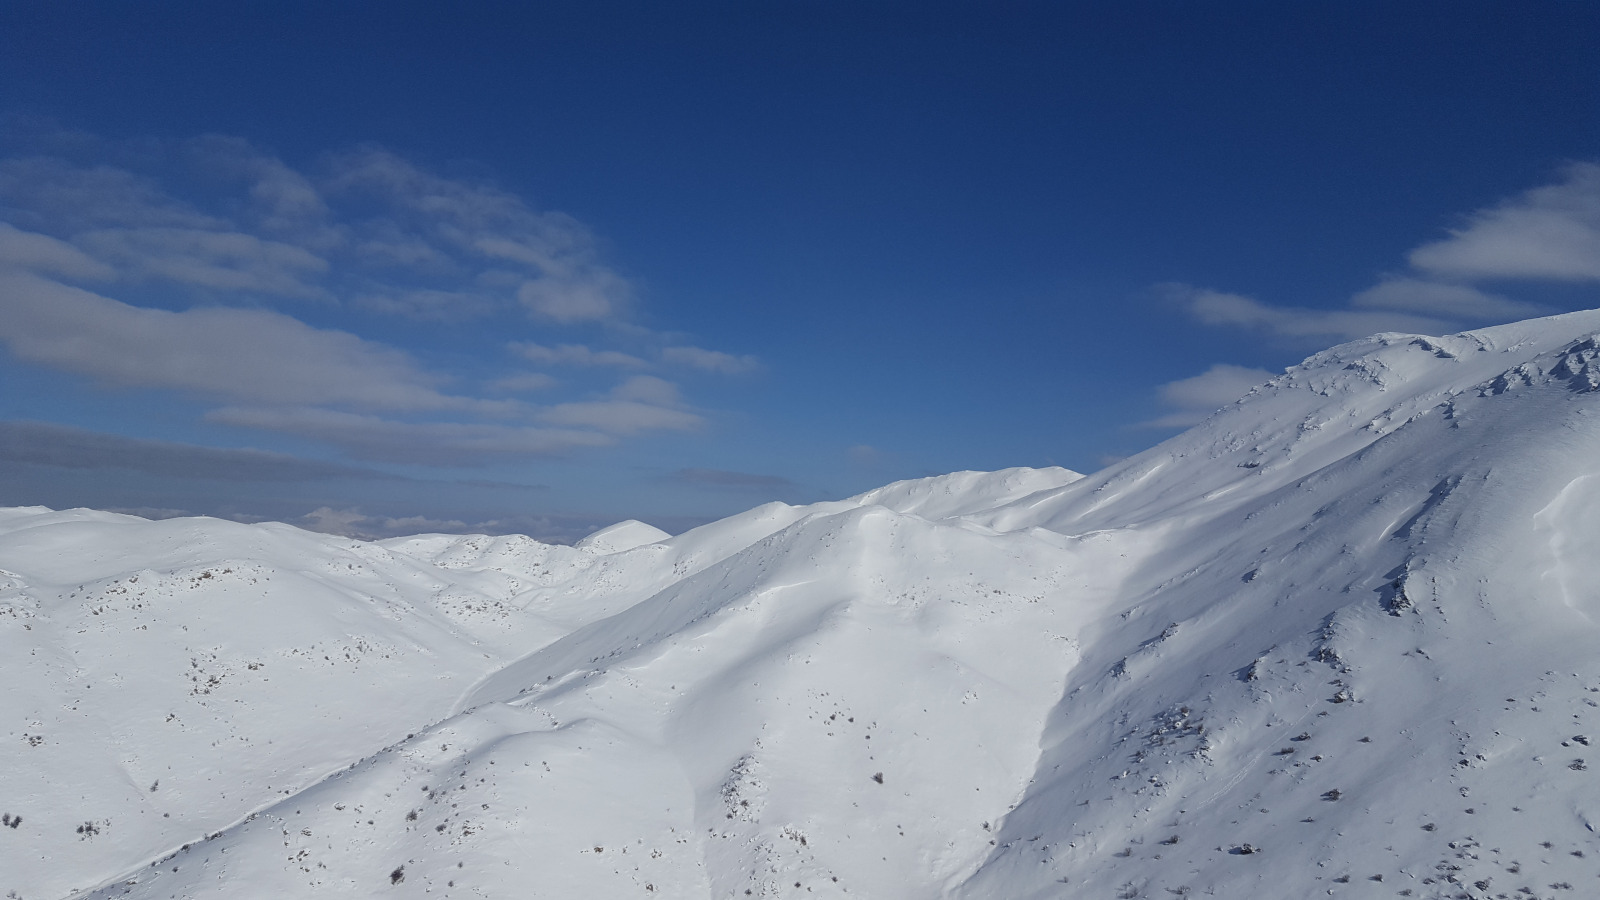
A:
[0, 145, 634, 325]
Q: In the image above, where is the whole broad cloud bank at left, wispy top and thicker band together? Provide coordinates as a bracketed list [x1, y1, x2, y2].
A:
[0, 136, 755, 464]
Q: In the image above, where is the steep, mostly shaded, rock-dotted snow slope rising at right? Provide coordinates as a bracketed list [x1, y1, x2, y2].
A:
[957, 314, 1600, 897]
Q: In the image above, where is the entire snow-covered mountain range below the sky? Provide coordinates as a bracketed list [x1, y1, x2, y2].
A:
[0, 312, 1600, 900]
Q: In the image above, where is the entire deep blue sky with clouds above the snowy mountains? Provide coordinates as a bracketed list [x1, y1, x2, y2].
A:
[0, 2, 1600, 540]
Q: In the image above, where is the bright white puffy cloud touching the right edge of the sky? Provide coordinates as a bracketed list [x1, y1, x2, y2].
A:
[1410, 163, 1600, 282]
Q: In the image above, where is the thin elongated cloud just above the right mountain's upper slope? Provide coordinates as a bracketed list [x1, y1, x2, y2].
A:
[1163, 285, 1446, 340]
